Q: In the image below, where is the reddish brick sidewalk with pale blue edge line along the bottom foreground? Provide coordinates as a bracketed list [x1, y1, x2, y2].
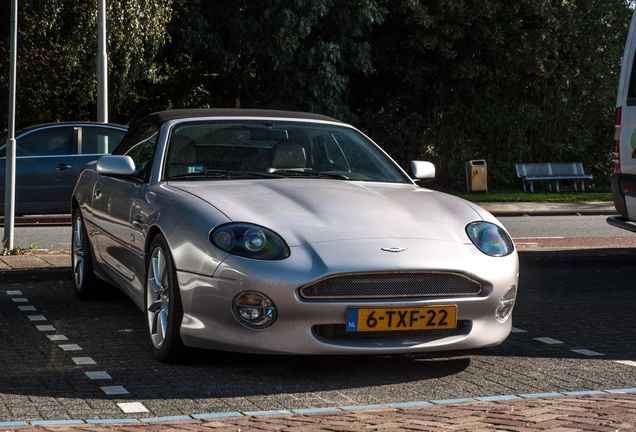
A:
[0, 389, 636, 432]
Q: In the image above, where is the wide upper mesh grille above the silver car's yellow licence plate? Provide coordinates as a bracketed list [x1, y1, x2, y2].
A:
[300, 272, 482, 299]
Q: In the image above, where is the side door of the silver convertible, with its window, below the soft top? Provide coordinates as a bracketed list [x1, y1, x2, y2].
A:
[92, 126, 158, 296]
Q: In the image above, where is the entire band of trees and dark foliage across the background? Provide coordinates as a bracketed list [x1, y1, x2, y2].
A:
[0, 0, 632, 190]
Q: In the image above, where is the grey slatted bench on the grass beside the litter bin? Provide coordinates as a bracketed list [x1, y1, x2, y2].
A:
[515, 162, 592, 193]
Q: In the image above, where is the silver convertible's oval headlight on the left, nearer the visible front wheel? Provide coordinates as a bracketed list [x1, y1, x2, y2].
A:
[210, 223, 289, 260]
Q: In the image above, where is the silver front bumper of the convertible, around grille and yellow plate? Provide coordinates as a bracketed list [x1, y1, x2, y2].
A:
[178, 239, 518, 354]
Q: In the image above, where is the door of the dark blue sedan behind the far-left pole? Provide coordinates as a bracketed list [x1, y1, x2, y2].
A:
[0, 126, 76, 215]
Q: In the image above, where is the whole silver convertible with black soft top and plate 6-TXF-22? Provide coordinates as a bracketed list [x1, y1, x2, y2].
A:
[72, 110, 519, 362]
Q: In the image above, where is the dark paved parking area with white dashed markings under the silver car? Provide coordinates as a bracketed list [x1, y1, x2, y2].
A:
[0, 246, 636, 421]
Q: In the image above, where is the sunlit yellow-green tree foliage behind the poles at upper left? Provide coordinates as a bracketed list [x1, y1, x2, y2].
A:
[0, 0, 171, 129]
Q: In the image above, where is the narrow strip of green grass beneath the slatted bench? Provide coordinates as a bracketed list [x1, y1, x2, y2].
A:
[453, 190, 612, 202]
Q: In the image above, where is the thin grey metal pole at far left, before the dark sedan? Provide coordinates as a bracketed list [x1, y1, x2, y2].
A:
[4, 0, 18, 249]
